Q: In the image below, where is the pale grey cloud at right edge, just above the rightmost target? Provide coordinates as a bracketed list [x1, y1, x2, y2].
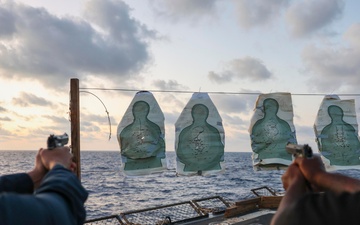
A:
[302, 24, 360, 92]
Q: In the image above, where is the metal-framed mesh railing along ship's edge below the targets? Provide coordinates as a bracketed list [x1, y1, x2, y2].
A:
[85, 186, 282, 225]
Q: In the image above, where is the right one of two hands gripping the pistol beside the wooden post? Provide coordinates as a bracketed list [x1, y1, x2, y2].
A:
[40, 146, 76, 172]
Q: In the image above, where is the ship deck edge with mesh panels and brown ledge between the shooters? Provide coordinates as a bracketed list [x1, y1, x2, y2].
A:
[85, 187, 282, 225]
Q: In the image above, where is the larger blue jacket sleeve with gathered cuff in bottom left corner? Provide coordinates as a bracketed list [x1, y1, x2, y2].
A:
[0, 165, 88, 225]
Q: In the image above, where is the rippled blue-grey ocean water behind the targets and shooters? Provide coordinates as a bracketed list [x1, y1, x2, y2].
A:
[0, 151, 360, 219]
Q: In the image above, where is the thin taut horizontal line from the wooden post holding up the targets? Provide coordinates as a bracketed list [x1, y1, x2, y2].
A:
[79, 87, 360, 96]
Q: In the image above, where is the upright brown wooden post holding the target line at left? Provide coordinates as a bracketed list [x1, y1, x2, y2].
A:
[70, 78, 81, 180]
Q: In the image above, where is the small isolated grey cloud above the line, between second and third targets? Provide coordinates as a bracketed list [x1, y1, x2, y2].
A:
[208, 57, 272, 84]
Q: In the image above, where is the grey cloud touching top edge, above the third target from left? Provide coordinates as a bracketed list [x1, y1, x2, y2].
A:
[233, 0, 289, 29]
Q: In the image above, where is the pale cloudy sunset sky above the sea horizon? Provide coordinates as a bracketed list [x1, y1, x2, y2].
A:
[0, 0, 360, 152]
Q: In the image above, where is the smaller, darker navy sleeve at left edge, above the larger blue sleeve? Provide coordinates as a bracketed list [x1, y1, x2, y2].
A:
[0, 173, 34, 194]
